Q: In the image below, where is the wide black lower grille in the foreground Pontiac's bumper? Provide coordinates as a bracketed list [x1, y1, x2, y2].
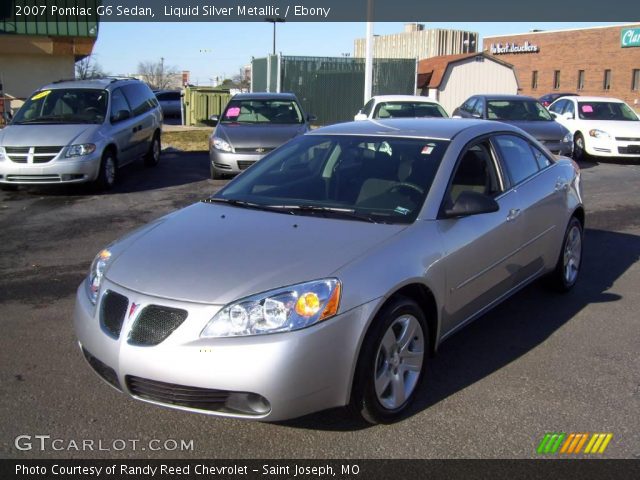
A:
[126, 375, 231, 410]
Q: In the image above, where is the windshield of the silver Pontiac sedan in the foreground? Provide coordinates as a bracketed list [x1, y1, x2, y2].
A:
[210, 135, 449, 223]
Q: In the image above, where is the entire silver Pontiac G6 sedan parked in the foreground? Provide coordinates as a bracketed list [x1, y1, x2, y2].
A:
[75, 119, 585, 423]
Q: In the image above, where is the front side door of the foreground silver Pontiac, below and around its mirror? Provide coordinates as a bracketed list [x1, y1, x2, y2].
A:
[438, 138, 522, 335]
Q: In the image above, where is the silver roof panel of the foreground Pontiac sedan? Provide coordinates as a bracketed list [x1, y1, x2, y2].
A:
[307, 118, 519, 140]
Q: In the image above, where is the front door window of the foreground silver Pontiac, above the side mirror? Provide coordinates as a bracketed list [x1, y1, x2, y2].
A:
[447, 141, 501, 205]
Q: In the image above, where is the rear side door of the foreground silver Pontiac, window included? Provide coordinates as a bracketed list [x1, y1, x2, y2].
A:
[493, 134, 571, 283]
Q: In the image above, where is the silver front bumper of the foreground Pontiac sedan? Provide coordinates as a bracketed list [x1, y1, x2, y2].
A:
[74, 280, 377, 421]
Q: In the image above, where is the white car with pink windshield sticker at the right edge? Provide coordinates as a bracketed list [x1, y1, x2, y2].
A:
[549, 97, 640, 160]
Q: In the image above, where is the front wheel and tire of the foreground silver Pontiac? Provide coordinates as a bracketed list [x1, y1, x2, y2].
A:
[350, 297, 429, 424]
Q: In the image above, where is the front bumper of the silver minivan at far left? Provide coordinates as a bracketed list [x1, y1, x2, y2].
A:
[0, 152, 101, 185]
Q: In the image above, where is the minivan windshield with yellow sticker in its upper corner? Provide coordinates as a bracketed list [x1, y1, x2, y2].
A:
[12, 88, 108, 125]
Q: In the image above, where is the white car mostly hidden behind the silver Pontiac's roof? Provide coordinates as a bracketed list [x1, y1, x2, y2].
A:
[353, 95, 449, 120]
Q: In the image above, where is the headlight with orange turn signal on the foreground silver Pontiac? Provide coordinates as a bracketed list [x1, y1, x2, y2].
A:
[200, 278, 341, 337]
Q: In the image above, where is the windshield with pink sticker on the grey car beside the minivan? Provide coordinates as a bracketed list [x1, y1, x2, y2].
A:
[222, 100, 303, 124]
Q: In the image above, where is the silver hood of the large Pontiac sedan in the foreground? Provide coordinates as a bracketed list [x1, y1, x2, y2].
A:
[105, 203, 406, 305]
